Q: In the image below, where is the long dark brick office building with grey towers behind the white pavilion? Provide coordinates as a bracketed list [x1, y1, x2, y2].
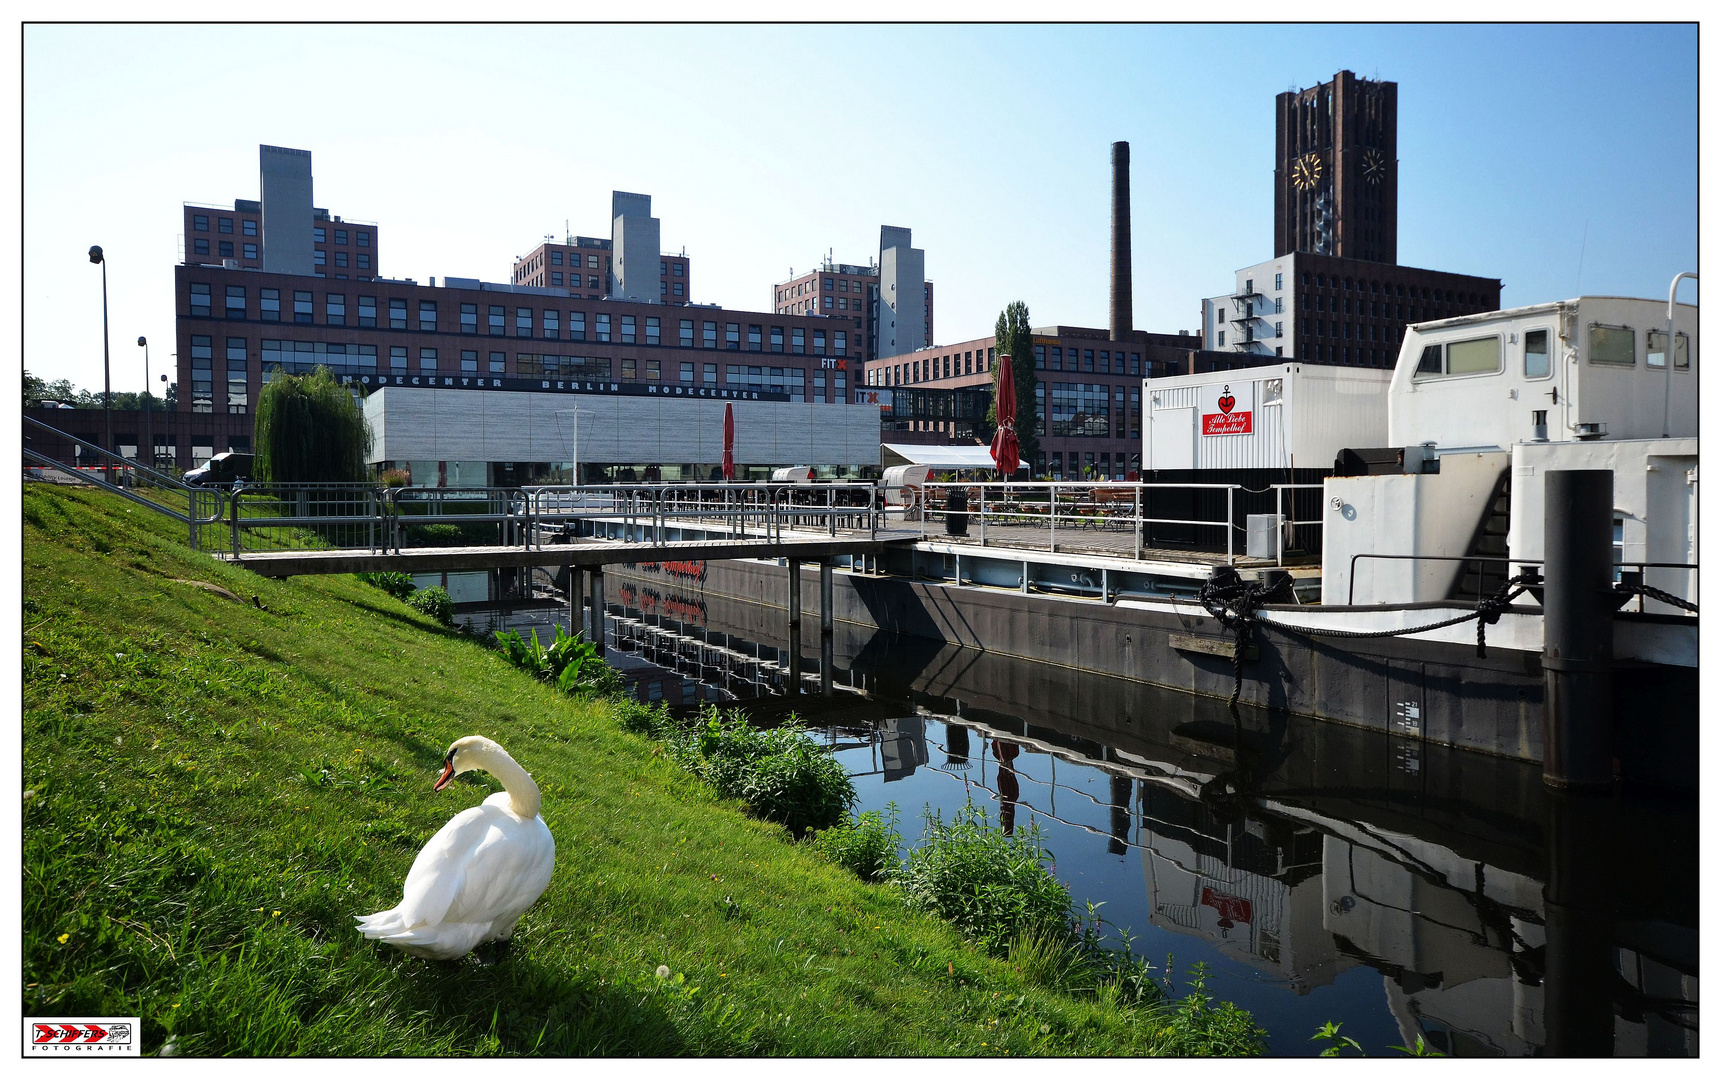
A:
[154, 146, 861, 468]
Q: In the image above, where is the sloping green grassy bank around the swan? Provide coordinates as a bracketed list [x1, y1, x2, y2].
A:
[22, 485, 1266, 1056]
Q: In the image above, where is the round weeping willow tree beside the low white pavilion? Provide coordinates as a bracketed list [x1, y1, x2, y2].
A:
[255, 366, 370, 483]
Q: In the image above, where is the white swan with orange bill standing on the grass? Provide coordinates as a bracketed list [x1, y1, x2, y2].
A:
[356, 734, 556, 960]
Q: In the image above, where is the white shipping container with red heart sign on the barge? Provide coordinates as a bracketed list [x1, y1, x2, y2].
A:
[1141, 363, 1392, 469]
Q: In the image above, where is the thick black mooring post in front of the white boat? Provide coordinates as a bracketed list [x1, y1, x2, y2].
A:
[1542, 469, 1614, 788]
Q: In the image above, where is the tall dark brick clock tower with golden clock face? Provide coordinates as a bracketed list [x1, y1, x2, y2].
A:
[1274, 71, 1397, 263]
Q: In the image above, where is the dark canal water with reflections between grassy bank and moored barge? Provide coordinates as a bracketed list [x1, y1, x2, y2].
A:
[468, 586, 1699, 1058]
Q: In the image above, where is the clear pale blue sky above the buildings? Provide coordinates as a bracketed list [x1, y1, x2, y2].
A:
[22, 26, 1699, 390]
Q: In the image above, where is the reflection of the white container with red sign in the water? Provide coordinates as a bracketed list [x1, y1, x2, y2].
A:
[1139, 784, 1354, 994]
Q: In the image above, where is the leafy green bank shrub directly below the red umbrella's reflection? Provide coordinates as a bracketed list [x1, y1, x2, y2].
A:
[898, 803, 1070, 953]
